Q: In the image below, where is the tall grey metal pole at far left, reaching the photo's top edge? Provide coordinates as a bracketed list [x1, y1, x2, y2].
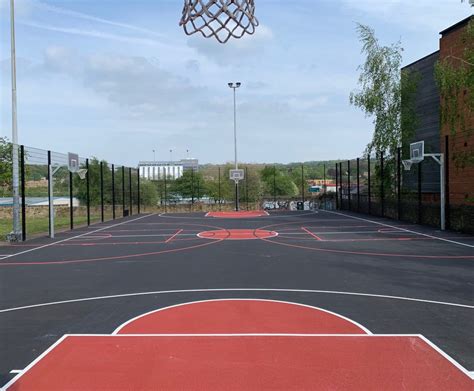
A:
[10, 0, 21, 241]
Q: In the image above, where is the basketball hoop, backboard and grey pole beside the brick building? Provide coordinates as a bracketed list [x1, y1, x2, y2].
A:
[403, 141, 446, 231]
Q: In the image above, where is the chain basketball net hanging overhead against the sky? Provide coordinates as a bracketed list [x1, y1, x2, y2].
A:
[179, 0, 258, 43]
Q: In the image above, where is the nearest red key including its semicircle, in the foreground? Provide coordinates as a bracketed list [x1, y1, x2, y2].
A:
[6, 299, 473, 391]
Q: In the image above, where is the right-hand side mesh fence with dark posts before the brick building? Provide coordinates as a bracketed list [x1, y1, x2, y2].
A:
[335, 136, 474, 233]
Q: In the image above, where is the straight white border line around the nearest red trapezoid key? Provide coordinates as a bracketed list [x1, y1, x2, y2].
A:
[0, 333, 474, 391]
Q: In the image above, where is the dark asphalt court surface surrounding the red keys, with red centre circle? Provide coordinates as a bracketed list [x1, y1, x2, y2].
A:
[0, 211, 474, 385]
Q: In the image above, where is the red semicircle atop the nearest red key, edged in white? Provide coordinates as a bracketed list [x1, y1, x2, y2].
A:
[114, 299, 370, 334]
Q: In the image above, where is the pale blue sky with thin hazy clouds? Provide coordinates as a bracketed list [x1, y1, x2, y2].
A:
[0, 0, 472, 166]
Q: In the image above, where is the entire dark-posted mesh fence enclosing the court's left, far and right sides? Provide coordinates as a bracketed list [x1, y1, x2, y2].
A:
[0, 137, 474, 239]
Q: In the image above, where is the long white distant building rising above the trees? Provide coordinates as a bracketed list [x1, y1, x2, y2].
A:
[138, 159, 199, 180]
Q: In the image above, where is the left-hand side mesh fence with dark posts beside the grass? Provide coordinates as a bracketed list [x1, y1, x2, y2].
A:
[0, 144, 140, 240]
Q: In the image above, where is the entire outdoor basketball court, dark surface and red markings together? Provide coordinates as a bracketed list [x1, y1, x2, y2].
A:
[0, 211, 474, 390]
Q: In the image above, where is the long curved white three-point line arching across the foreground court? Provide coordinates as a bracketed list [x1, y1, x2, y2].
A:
[0, 288, 474, 314]
